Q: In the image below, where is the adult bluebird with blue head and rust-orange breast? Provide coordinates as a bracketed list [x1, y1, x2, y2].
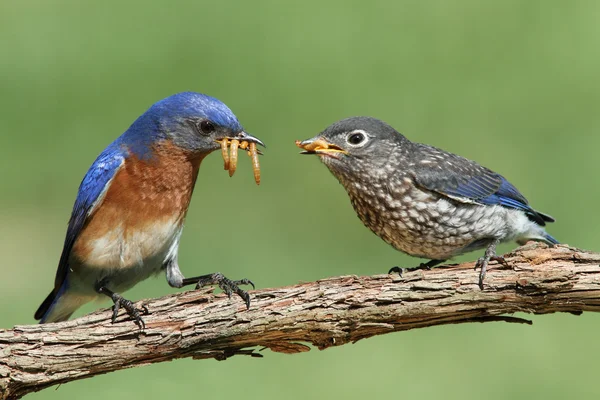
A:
[35, 92, 264, 328]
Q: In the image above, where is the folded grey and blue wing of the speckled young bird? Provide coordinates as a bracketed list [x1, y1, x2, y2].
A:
[414, 145, 554, 226]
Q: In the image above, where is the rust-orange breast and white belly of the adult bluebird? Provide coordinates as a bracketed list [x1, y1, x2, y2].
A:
[71, 142, 202, 268]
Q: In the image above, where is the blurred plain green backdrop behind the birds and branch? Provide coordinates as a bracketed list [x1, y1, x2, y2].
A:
[0, 0, 600, 400]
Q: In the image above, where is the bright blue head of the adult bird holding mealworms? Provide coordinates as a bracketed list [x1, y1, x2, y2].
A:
[121, 92, 262, 157]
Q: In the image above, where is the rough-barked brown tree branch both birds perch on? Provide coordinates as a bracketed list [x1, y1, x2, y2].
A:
[0, 244, 600, 399]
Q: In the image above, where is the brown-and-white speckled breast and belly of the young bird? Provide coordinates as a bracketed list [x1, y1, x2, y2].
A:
[342, 177, 504, 260]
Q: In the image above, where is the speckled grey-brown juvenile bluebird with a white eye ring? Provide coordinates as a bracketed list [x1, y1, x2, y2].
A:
[296, 117, 558, 288]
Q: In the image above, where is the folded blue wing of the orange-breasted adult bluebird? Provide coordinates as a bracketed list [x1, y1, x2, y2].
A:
[54, 140, 127, 291]
